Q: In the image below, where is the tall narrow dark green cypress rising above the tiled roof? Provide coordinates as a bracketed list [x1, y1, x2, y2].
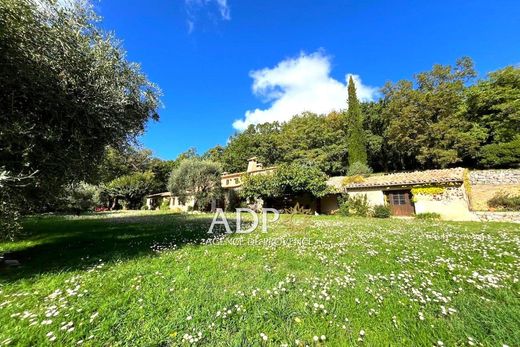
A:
[346, 76, 367, 166]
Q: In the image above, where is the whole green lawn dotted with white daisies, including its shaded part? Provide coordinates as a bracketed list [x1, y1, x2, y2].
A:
[0, 212, 520, 346]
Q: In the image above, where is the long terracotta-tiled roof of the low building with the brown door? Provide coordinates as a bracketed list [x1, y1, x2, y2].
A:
[345, 167, 464, 189]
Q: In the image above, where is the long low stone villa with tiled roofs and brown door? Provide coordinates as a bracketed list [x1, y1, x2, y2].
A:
[146, 157, 520, 221]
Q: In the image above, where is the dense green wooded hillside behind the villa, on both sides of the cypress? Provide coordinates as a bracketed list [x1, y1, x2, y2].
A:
[205, 58, 520, 175]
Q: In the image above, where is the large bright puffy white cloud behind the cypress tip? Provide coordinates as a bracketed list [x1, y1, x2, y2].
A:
[233, 52, 378, 130]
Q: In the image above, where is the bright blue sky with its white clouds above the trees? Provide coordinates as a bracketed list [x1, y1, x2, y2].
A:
[95, 0, 520, 159]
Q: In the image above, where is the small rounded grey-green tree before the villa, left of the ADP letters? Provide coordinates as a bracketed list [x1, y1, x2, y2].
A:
[168, 158, 222, 210]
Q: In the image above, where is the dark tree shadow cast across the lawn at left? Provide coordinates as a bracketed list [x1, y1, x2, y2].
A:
[0, 214, 231, 282]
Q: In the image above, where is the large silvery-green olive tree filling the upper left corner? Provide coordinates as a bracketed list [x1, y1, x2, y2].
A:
[0, 0, 159, 213]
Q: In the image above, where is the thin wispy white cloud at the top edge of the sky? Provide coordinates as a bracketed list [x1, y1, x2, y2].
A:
[184, 0, 231, 33]
